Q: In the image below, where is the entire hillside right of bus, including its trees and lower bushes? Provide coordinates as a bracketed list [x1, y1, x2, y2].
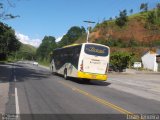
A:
[75, 3, 160, 69]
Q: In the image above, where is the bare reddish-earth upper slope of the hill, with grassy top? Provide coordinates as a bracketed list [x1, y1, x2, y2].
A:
[91, 11, 160, 46]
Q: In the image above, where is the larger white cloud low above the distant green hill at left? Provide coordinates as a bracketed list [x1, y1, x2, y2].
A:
[15, 32, 41, 47]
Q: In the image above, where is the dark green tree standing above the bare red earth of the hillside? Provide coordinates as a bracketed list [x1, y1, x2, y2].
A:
[116, 10, 128, 27]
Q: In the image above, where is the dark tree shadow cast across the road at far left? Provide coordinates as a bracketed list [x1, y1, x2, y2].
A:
[0, 64, 50, 83]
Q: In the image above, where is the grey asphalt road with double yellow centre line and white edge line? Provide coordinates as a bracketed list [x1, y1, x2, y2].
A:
[0, 63, 160, 120]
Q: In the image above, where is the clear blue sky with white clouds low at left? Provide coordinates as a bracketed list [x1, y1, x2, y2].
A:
[0, 0, 160, 47]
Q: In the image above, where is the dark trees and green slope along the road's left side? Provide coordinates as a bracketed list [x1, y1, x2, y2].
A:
[0, 23, 36, 61]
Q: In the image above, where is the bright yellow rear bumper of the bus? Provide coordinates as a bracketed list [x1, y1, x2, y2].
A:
[78, 71, 107, 81]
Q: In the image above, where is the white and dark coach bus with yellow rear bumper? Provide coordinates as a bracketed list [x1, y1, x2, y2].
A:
[50, 43, 110, 81]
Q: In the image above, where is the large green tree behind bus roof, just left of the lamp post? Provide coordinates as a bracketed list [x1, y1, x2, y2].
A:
[58, 26, 86, 47]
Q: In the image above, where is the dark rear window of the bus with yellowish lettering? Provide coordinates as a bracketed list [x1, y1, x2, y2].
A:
[84, 44, 108, 56]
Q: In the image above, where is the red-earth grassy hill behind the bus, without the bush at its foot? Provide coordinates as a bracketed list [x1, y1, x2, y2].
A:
[76, 9, 160, 61]
